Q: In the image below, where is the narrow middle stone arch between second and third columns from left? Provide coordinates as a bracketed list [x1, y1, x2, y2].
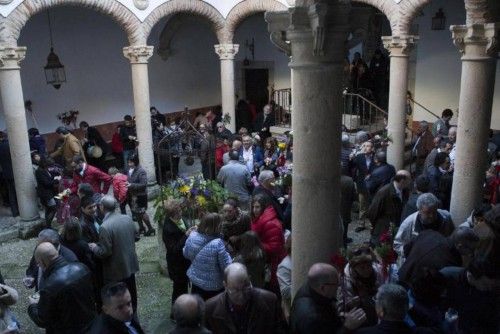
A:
[142, 0, 224, 41]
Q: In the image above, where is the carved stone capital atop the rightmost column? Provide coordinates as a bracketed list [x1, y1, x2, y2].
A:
[450, 23, 500, 60]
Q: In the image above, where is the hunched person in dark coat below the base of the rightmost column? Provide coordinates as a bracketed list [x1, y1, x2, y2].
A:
[398, 227, 479, 284]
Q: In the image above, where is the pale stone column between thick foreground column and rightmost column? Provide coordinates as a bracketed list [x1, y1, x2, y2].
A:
[382, 36, 418, 170]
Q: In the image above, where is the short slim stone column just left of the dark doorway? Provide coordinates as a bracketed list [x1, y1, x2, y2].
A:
[214, 44, 240, 133]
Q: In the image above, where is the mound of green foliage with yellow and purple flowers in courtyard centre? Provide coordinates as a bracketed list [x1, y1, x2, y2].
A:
[154, 173, 228, 221]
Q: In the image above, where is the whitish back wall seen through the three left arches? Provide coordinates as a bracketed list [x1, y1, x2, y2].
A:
[0, 7, 290, 133]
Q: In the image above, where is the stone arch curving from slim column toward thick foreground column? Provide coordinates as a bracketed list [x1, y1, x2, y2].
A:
[223, 0, 287, 43]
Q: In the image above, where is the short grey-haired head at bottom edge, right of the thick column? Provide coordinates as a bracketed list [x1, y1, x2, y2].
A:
[376, 284, 409, 321]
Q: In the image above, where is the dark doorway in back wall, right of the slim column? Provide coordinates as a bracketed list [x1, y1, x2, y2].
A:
[245, 68, 269, 113]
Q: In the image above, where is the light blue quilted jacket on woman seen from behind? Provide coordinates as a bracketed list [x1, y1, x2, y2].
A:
[182, 231, 232, 291]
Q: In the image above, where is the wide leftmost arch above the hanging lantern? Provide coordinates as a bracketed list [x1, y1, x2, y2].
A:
[0, 0, 146, 46]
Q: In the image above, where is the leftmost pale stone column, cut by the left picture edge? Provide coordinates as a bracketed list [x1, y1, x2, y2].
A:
[0, 47, 38, 221]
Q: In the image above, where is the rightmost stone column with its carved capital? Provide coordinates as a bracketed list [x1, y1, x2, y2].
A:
[450, 23, 500, 225]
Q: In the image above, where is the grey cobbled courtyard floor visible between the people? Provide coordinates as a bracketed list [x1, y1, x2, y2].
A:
[0, 198, 368, 334]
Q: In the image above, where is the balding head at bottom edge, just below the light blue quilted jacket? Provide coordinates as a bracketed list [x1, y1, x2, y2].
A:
[173, 294, 205, 328]
